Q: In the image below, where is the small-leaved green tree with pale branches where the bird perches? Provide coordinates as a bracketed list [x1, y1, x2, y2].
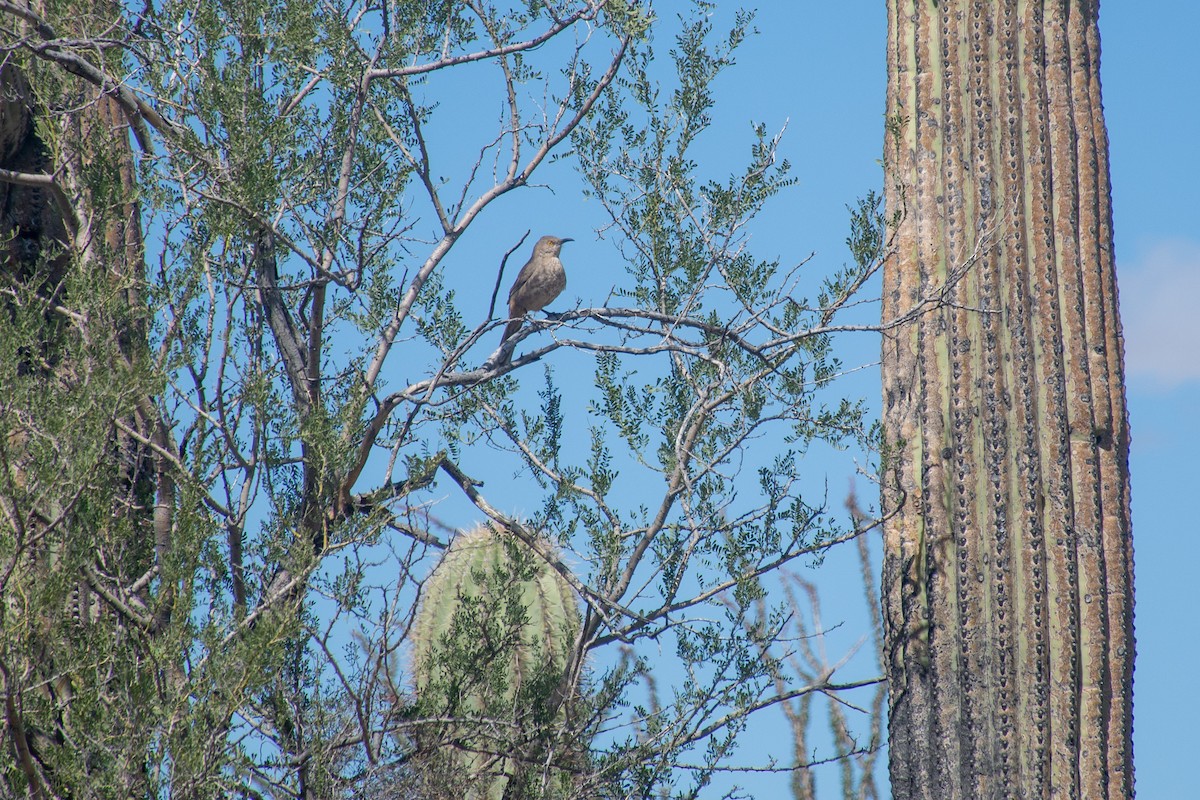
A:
[0, 0, 883, 798]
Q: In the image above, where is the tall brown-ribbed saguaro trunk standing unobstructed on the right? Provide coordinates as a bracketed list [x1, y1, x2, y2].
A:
[883, 0, 1134, 799]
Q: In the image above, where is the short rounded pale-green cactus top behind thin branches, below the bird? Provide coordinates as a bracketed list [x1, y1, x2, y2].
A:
[412, 525, 580, 800]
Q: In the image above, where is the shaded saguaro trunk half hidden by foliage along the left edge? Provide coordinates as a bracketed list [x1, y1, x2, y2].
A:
[0, 0, 165, 798]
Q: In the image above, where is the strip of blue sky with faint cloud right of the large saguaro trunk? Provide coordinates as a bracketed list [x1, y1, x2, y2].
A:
[1100, 0, 1200, 798]
